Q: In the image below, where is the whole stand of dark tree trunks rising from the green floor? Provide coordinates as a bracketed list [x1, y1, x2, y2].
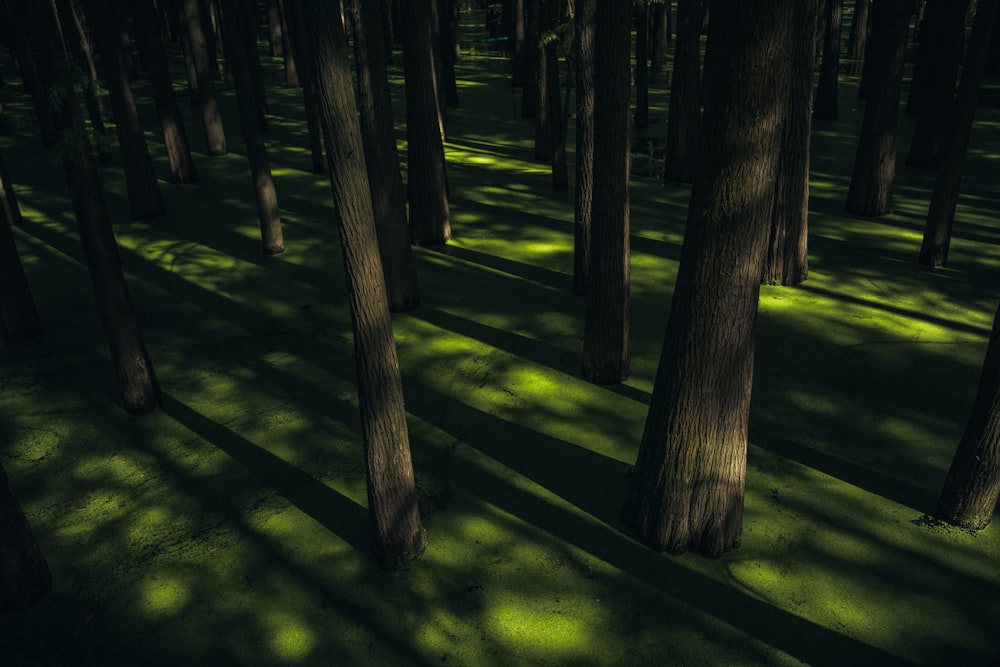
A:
[0, 0, 1000, 611]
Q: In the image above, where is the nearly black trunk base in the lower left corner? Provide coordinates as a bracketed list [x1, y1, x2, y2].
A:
[0, 465, 52, 614]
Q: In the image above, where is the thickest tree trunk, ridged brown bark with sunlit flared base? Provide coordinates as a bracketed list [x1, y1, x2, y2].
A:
[623, 0, 813, 557]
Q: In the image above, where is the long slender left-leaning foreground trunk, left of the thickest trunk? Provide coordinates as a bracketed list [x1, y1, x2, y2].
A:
[303, 0, 426, 570]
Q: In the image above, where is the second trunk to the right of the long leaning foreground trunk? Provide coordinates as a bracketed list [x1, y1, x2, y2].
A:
[400, 0, 451, 245]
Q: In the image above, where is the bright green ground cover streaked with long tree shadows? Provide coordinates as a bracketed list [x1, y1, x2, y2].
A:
[0, 23, 1000, 667]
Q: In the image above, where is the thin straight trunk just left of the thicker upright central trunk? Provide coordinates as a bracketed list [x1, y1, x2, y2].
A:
[573, 0, 597, 294]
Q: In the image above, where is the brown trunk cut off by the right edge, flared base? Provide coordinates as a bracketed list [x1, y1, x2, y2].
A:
[936, 296, 1000, 530]
